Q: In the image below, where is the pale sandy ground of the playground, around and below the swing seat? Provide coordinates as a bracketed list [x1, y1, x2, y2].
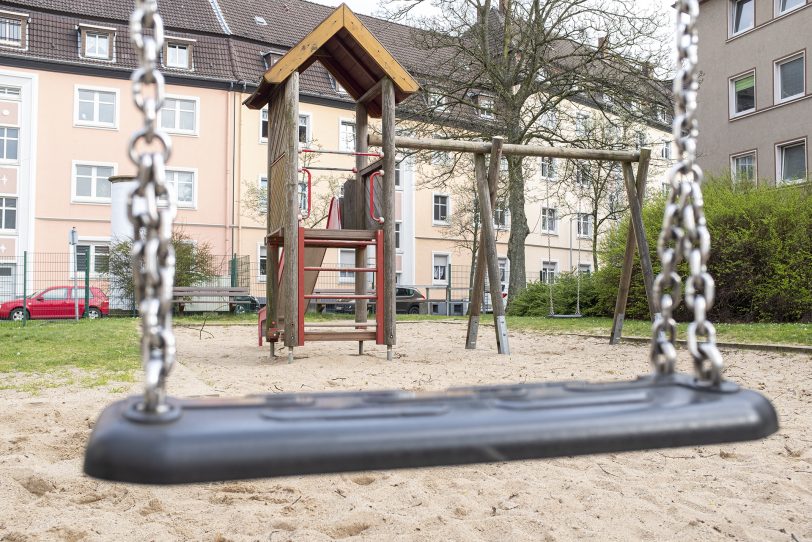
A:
[0, 322, 812, 542]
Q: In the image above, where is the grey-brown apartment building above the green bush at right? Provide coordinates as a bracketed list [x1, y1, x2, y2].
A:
[697, 0, 812, 186]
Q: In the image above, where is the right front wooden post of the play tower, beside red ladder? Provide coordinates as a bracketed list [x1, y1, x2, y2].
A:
[380, 77, 397, 360]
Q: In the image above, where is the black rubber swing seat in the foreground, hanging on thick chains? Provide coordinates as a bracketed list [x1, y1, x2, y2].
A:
[84, 375, 778, 484]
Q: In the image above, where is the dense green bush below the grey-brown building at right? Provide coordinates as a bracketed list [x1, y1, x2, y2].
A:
[591, 179, 812, 322]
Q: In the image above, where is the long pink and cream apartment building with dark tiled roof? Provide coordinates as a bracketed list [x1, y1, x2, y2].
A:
[0, 0, 671, 306]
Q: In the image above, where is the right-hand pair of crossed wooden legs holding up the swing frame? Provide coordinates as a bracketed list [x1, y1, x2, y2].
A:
[609, 149, 657, 344]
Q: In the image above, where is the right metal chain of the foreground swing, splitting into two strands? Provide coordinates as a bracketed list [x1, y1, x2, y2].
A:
[651, 0, 723, 385]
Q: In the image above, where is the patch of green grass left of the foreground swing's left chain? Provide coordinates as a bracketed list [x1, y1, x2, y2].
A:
[0, 318, 140, 392]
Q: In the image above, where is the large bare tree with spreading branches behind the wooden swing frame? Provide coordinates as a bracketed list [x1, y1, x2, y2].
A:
[389, 0, 668, 306]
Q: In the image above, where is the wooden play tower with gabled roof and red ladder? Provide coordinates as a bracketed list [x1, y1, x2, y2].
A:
[245, 4, 419, 361]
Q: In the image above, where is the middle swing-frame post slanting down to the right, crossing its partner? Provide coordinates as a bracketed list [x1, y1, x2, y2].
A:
[474, 137, 510, 354]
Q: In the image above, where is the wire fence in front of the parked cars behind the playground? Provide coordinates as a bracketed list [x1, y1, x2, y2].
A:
[0, 253, 552, 325]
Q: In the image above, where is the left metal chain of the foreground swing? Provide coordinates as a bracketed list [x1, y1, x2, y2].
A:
[127, 0, 176, 413]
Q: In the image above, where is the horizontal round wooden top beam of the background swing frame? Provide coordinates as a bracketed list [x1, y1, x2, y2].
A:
[369, 134, 640, 162]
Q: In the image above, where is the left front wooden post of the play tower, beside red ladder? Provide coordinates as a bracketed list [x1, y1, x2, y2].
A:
[281, 72, 304, 362]
